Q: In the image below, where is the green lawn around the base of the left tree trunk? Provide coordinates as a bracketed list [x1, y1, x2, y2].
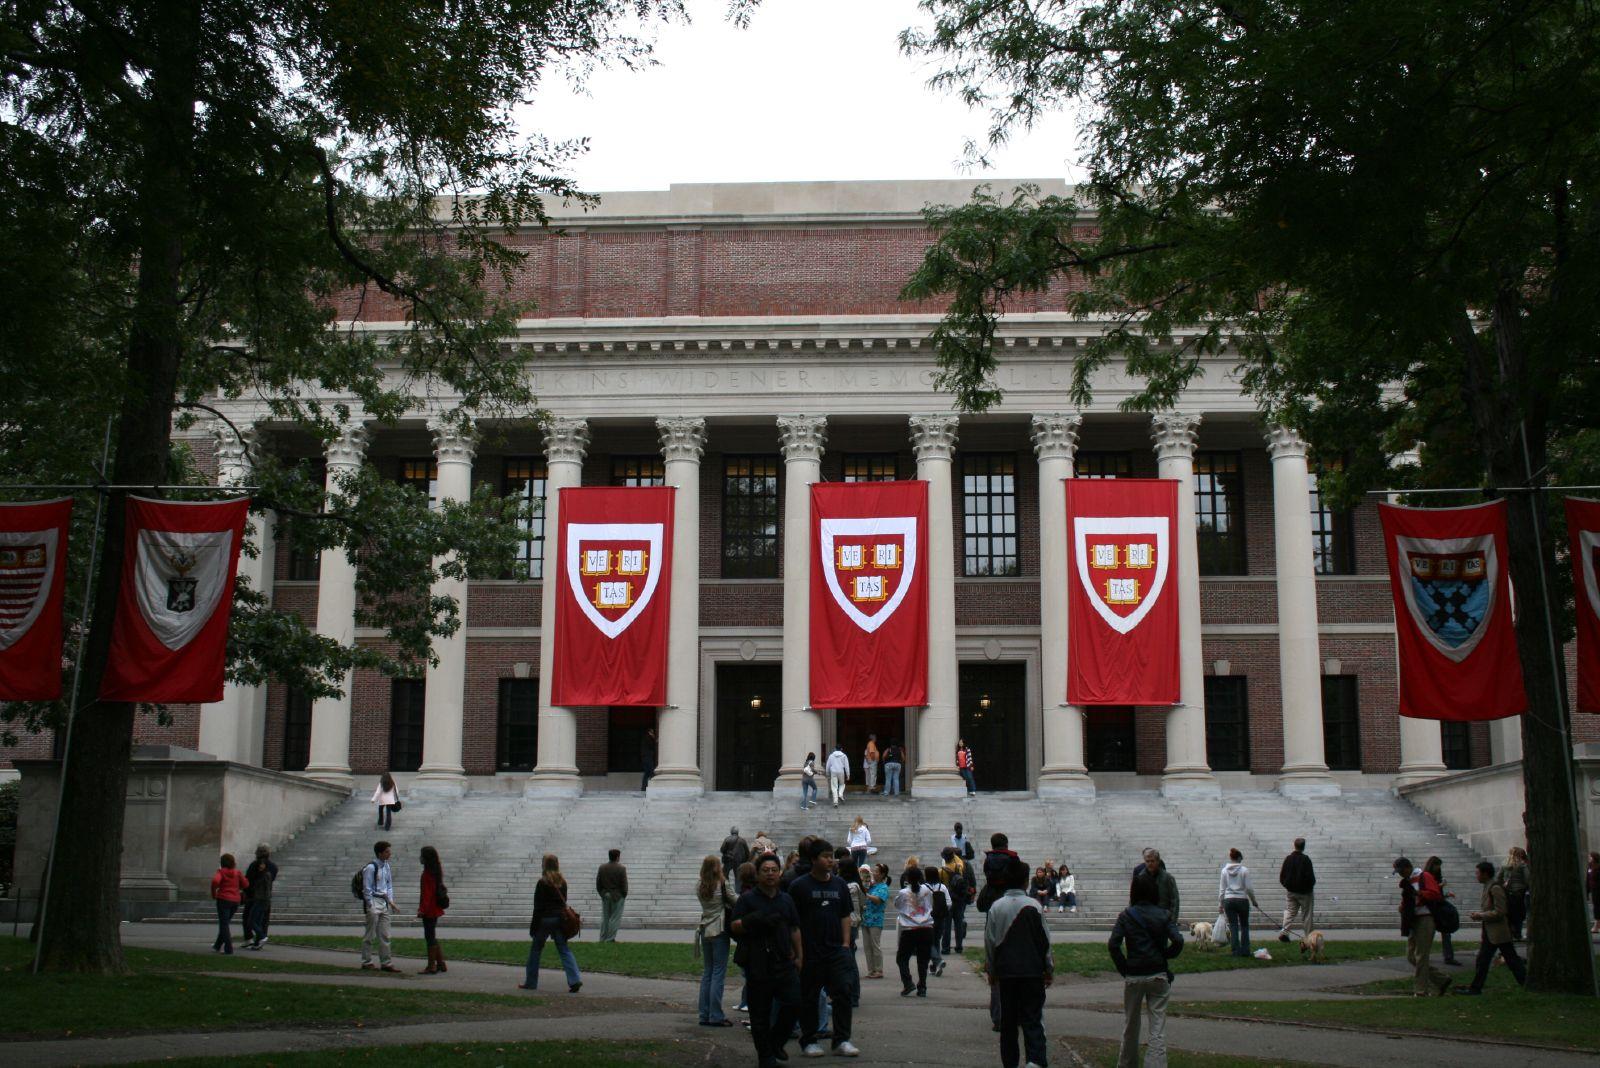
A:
[0, 938, 538, 1039]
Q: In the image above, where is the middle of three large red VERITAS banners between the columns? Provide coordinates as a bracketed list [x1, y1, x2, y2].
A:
[811, 481, 928, 708]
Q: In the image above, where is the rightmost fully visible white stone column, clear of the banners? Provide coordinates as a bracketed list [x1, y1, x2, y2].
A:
[1267, 427, 1339, 798]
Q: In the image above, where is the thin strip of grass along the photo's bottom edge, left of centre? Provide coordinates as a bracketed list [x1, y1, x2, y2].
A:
[131, 1039, 694, 1068]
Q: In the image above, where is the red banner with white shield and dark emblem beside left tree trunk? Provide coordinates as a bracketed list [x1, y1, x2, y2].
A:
[99, 497, 250, 703]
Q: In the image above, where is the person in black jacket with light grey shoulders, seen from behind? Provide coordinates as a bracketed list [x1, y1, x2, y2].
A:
[984, 860, 1056, 1068]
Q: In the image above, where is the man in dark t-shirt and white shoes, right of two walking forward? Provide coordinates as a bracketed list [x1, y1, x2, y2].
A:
[789, 838, 861, 1057]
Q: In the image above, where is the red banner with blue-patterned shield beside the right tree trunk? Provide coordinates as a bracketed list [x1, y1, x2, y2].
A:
[1378, 500, 1528, 719]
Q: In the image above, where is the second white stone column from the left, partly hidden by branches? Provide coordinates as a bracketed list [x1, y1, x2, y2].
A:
[306, 424, 368, 787]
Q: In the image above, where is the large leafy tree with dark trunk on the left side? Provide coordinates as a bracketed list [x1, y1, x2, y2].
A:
[0, 0, 680, 972]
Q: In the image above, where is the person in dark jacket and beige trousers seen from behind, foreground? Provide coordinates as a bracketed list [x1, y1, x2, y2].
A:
[1106, 871, 1184, 1068]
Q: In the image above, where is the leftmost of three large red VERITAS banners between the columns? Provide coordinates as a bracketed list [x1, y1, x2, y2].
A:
[550, 486, 672, 707]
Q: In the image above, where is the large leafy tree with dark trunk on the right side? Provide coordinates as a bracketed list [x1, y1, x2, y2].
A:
[902, 0, 1600, 994]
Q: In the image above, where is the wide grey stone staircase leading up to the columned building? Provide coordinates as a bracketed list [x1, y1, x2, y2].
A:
[170, 790, 1478, 929]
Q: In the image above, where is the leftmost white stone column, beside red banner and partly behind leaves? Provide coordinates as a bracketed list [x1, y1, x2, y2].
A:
[198, 420, 274, 767]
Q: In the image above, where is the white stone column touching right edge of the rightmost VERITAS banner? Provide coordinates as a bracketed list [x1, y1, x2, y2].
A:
[1150, 412, 1221, 798]
